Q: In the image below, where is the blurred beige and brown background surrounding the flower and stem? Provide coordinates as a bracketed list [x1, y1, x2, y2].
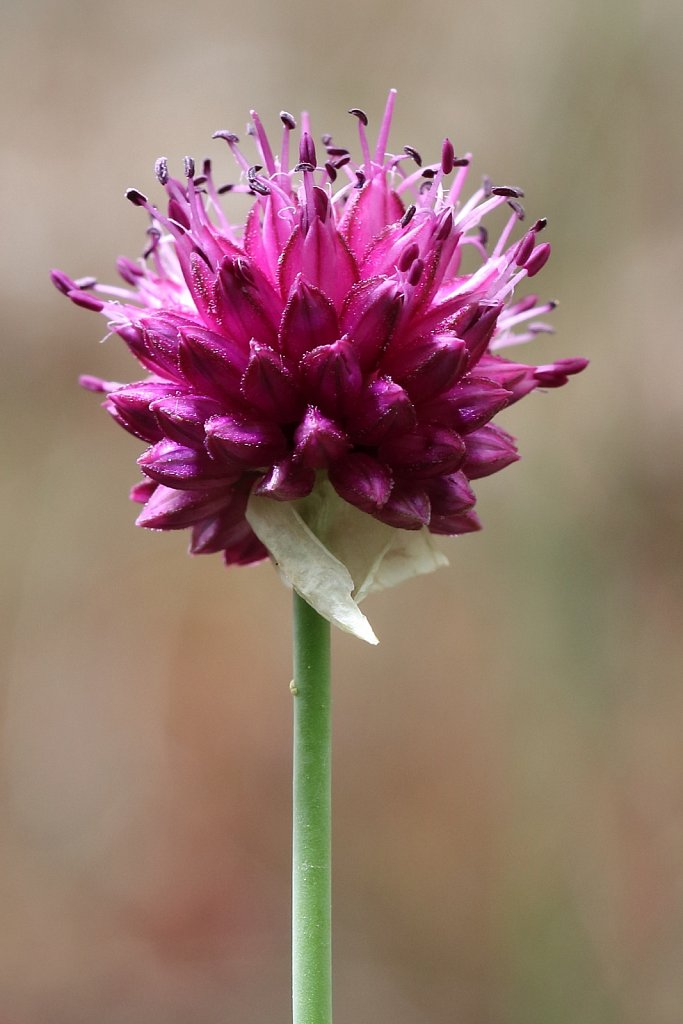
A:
[0, 0, 683, 1024]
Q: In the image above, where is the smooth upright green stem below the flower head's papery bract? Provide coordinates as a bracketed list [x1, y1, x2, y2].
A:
[292, 593, 332, 1024]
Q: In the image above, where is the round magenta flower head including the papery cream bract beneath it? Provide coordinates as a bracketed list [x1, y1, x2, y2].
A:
[52, 91, 586, 640]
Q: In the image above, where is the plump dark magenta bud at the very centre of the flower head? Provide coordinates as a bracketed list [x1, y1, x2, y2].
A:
[301, 338, 362, 420]
